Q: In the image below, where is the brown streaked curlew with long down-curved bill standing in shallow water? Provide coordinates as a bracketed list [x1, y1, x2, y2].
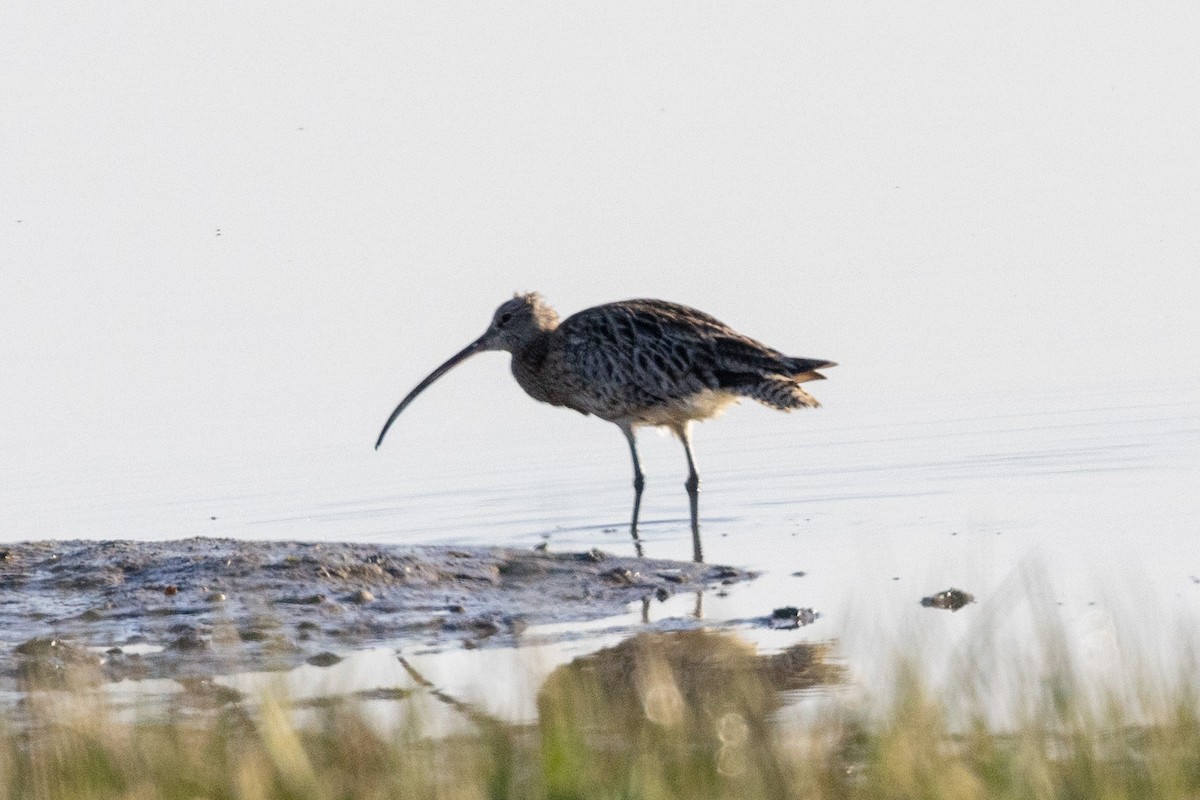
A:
[376, 291, 838, 563]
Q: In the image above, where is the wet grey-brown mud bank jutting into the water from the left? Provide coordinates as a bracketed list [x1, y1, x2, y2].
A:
[0, 539, 751, 687]
